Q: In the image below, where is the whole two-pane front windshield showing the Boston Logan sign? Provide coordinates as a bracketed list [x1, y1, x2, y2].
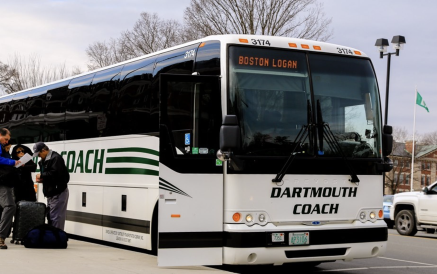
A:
[228, 46, 381, 158]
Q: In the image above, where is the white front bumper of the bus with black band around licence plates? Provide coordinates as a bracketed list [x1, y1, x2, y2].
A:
[223, 220, 388, 265]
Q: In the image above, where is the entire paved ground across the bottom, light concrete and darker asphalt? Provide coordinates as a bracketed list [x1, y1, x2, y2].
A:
[0, 230, 437, 274]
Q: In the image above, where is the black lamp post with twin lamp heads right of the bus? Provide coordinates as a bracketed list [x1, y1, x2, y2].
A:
[375, 35, 406, 125]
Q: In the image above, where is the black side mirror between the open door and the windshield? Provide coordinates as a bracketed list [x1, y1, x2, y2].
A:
[220, 115, 240, 152]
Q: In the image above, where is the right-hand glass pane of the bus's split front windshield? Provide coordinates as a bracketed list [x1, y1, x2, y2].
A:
[309, 54, 380, 158]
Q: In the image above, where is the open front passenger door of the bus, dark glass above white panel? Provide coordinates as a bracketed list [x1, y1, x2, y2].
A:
[158, 74, 223, 266]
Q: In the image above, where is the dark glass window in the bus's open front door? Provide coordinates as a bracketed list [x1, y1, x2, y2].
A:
[166, 78, 221, 157]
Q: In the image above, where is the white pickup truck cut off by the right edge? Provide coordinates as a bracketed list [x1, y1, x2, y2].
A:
[390, 182, 437, 236]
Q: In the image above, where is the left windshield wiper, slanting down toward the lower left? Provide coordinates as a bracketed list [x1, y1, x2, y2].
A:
[272, 100, 314, 183]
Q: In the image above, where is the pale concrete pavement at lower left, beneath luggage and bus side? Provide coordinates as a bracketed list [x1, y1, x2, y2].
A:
[0, 238, 232, 274]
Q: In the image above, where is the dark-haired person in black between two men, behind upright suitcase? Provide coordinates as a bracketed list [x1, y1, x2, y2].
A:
[11, 145, 36, 203]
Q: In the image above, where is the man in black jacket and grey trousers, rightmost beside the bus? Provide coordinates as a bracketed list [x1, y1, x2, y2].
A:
[33, 142, 70, 230]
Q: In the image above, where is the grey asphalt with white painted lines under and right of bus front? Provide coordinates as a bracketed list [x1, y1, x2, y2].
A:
[214, 229, 437, 274]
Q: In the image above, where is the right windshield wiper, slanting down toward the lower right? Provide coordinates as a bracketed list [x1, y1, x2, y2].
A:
[317, 100, 360, 185]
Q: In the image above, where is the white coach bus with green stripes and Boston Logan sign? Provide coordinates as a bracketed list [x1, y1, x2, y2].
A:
[0, 35, 392, 266]
